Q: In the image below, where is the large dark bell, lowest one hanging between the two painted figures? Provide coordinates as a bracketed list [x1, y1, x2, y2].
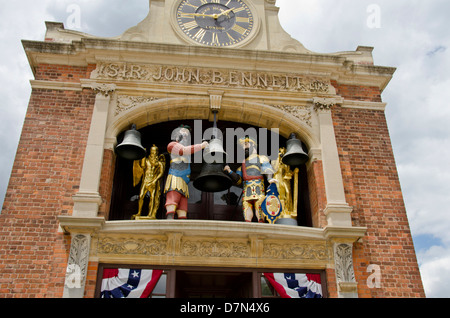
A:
[194, 163, 233, 193]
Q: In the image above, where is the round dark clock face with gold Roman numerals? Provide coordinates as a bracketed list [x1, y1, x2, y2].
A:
[176, 0, 254, 47]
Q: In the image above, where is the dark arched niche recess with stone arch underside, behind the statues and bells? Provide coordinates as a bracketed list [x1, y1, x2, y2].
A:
[107, 97, 318, 226]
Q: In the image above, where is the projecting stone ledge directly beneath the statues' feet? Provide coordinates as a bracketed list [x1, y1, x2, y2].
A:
[58, 216, 367, 241]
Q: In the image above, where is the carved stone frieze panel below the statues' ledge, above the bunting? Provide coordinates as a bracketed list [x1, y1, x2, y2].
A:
[93, 233, 330, 266]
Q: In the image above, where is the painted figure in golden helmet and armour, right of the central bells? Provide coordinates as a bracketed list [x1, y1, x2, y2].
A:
[224, 137, 276, 223]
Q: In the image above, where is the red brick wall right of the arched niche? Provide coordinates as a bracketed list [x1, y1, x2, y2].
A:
[332, 90, 425, 297]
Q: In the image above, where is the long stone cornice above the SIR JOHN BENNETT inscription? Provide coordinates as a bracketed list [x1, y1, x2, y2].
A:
[22, 39, 395, 89]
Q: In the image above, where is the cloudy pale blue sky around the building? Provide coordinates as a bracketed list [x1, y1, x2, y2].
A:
[0, 0, 450, 298]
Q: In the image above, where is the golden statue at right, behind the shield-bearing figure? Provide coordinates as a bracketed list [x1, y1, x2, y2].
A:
[272, 148, 299, 219]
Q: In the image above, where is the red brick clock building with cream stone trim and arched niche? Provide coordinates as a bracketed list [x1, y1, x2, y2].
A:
[0, 0, 424, 298]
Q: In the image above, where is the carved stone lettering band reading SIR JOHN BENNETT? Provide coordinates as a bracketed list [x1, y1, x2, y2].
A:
[92, 63, 331, 93]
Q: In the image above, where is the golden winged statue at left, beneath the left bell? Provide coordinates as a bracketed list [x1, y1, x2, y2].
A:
[131, 145, 166, 220]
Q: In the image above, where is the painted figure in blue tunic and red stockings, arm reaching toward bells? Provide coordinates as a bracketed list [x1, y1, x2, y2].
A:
[164, 125, 208, 219]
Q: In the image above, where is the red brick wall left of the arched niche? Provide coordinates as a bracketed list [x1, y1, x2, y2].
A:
[0, 65, 95, 298]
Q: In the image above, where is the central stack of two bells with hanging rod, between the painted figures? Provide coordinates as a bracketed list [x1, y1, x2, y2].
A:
[194, 113, 233, 193]
